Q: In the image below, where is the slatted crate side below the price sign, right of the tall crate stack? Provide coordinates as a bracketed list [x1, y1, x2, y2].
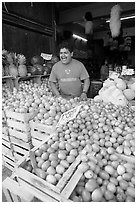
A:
[29, 120, 56, 147]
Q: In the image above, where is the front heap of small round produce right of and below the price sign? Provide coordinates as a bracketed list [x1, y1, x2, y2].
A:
[24, 99, 135, 202]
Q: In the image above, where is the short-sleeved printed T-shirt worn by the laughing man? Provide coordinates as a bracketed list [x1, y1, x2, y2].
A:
[49, 59, 89, 97]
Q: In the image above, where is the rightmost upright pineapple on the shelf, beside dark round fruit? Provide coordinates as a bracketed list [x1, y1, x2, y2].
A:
[17, 54, 27, 77]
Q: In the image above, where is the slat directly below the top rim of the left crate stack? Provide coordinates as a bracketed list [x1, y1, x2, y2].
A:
[7, 118, 30, 132]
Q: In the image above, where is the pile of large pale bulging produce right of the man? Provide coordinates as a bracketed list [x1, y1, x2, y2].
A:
[95, 73, 135, 106]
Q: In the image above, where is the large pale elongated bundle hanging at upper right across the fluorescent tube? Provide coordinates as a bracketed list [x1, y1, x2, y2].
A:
[109, 4, 121, 38]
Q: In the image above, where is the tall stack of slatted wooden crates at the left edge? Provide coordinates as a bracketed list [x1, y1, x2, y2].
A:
[5, 110, 36, 164]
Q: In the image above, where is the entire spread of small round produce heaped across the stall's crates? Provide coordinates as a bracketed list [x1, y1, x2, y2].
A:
[2, 78, 135, 202]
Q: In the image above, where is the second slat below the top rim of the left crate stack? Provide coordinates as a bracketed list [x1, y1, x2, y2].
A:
[9, 128, 31, 142]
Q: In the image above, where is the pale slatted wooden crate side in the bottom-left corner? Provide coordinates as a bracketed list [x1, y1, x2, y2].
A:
[2, 174, 69, 202]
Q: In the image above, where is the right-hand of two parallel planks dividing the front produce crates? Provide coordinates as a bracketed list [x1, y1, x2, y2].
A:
[61, 170, 83, 199]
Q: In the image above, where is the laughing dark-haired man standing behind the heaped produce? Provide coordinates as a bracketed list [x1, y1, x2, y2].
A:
[49, 42, 90, 99]
